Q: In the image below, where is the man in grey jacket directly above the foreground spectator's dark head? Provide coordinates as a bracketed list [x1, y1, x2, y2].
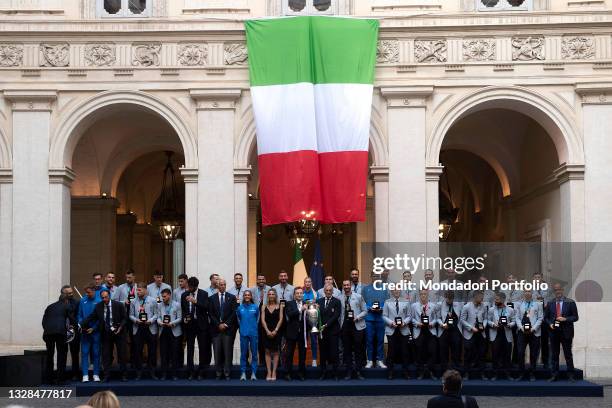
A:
[436, 290, 463, 372]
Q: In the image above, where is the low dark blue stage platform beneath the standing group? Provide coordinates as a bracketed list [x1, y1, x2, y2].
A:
[70, 368, 603, 397]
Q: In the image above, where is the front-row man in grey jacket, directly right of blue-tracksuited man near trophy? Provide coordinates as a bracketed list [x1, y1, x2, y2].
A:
[383, 289, 412, 380]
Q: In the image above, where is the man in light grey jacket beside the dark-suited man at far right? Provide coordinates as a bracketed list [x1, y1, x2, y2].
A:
[514, 290, 543, 381]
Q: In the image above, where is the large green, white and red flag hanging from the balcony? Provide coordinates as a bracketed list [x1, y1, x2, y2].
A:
[245, 17, 378, 225]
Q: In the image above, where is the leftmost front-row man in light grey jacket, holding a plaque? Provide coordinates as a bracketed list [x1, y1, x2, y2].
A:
[130, 283, 158, 380]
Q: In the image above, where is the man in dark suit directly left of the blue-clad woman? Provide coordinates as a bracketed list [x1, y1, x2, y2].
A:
[208, 279, 238, 380]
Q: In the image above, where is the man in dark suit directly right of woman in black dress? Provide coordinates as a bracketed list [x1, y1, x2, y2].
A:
[285, 286, 306, 381]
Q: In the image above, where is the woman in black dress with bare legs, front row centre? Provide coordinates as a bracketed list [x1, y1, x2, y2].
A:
[261, 289, 284, 381]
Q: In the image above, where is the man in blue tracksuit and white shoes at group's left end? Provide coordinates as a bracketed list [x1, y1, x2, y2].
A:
[77, 283, 100, 382]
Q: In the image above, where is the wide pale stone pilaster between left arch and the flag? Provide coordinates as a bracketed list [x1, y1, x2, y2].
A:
[188, 88, 241, 283]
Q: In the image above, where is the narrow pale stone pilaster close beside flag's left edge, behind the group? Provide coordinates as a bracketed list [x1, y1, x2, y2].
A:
[234, 168, 255, 286]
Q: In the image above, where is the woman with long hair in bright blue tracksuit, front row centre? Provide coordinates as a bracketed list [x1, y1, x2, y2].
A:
[236, 289, 259, 381]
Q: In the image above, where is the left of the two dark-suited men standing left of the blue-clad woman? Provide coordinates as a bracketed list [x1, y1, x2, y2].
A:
[181, 276, 211, 380]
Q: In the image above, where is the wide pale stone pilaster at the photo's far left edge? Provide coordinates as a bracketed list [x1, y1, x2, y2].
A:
[0, 90, 56, 344]
